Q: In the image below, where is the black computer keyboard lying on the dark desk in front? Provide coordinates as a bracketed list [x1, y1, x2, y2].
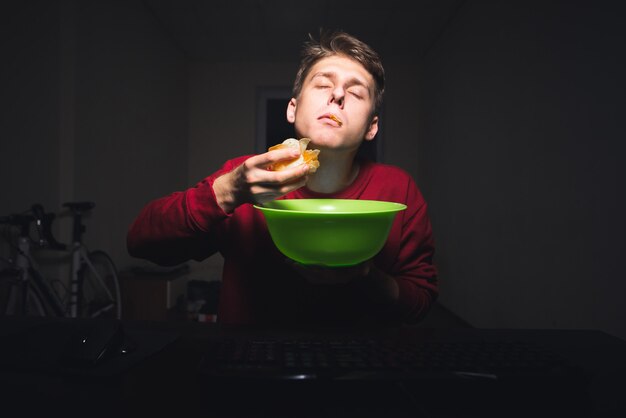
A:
[200, 338, 582, 382]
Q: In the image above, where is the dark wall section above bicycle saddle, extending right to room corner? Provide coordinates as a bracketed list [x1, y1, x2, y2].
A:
[74, 1, 188, 268]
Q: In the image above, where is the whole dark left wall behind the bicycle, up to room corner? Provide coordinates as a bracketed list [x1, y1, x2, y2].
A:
[0, 1, 188, 276]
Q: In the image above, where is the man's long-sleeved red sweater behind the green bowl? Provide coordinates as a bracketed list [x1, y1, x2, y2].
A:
[127, 156, 438, 325]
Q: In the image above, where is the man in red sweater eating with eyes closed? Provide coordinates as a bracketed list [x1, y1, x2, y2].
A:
[127, 32, 438, 325]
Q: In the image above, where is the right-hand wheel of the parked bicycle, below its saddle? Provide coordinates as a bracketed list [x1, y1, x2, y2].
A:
[78, 251, 122, 319]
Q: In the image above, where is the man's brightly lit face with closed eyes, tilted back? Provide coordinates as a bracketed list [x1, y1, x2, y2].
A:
[287, 55, 378, 150]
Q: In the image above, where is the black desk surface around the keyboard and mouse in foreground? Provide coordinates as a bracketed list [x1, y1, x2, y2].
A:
[0, 318, 626, 418]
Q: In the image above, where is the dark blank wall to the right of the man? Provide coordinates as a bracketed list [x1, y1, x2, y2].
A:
[418, 2, 626, 337]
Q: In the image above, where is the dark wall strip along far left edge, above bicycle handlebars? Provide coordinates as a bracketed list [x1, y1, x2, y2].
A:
[0, 2, 60, 222]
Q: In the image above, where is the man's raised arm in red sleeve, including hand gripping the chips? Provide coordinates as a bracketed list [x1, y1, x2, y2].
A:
[126, 149, 308, 265]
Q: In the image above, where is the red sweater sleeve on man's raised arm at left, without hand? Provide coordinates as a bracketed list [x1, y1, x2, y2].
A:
[126, 157, 245, 266]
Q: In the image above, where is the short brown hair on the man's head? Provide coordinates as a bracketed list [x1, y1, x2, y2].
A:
[292, 30, 385, 114]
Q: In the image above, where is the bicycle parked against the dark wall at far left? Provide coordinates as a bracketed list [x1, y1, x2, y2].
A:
[0, 202, 122, 319]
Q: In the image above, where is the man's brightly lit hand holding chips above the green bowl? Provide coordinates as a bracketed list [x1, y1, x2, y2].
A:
[213, 149, 309, 213]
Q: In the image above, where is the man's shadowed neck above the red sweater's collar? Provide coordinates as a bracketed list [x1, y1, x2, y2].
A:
[307, 155, 359, 193]
